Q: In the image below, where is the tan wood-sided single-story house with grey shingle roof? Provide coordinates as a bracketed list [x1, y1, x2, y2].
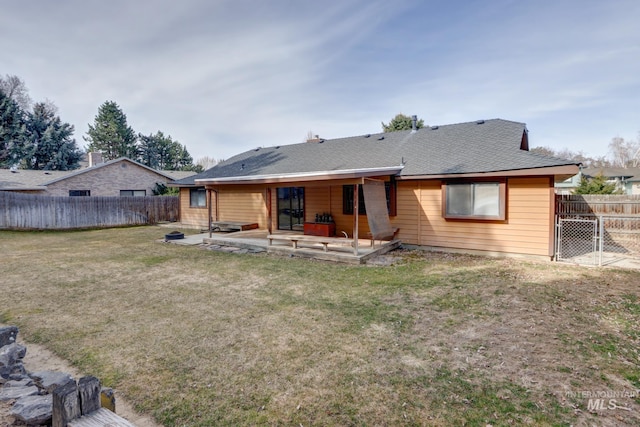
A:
[172, 119, 578, 257]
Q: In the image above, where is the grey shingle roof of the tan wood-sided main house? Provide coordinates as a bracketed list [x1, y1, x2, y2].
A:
[172, 119, 578, 186]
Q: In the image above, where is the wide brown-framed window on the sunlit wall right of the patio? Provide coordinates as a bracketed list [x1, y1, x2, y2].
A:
[442, 182, 506, 220]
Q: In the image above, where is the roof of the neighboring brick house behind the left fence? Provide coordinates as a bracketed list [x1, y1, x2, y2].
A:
[0, 157, 195, 191]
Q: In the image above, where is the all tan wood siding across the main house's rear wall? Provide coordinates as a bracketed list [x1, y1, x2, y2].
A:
[180, 177, 554, 256]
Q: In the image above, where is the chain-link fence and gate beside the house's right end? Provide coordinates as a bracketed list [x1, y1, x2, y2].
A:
[555, 215, 640, 268]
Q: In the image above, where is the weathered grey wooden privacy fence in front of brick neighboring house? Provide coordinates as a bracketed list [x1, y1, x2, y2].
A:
[0, 191, 180, 230]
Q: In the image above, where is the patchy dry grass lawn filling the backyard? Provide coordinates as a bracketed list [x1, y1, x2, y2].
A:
[0, 227, 640, 426]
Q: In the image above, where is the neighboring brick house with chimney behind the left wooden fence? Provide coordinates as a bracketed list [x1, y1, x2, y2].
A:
[0, 156, 195, 196]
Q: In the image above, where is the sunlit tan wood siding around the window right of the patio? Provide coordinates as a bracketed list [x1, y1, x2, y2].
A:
[416, 177, 553, 256]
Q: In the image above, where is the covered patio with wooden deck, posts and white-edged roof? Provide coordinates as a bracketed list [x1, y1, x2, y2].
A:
[196, 165, 403, 264]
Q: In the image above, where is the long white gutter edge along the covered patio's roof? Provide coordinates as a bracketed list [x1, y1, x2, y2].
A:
[195, 165, 404, 185]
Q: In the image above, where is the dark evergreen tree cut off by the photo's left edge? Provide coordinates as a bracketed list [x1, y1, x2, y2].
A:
[0, 90, 27, 168]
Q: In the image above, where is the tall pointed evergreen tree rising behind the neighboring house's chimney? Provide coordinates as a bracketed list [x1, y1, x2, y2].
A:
[84, 101, 138, 160]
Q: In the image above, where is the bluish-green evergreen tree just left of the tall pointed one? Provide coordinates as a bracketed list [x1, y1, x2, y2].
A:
[23, 102, 82, 170]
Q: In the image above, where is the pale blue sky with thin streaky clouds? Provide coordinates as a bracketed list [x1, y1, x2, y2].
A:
[0, 0, 640, 159]
